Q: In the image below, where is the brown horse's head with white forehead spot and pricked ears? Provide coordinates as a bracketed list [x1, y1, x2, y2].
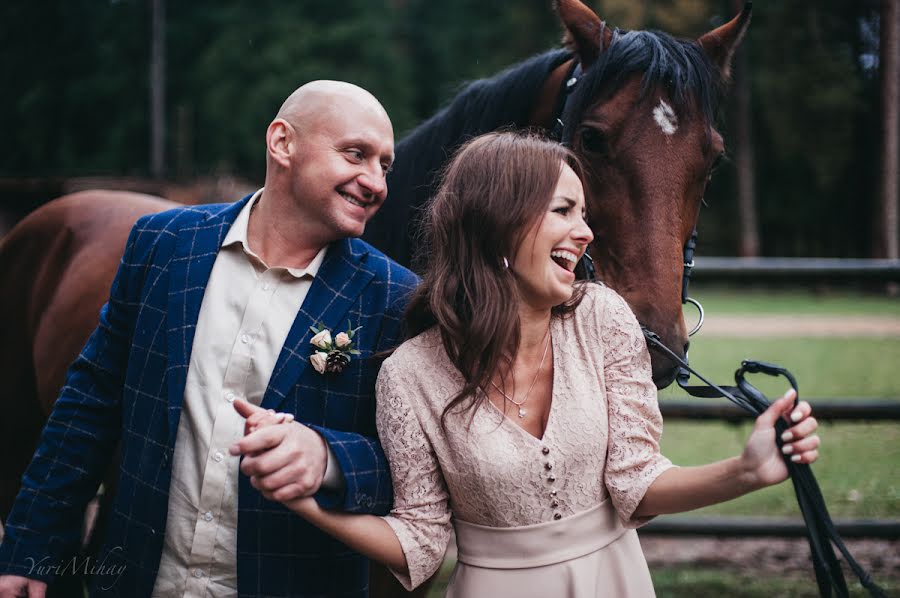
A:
[533, 0, 750, 388]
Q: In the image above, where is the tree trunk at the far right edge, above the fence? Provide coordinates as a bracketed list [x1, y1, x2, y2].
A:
[876, 0, 900, 259]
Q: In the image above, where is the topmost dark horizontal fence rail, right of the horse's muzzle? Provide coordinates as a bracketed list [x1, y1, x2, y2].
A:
[693, 257, 900, 282]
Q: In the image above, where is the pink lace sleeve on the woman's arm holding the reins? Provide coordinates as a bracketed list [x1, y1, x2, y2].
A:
[596, 291, 672, 527]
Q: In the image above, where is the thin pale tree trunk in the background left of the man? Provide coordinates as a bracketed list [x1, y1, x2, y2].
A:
[150, 0, 166, 179]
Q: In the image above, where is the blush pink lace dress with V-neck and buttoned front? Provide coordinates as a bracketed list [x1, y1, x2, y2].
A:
[377, 284, 672, 598]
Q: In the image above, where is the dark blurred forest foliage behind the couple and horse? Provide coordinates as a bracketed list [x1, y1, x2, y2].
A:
[0, 0, 879, 256]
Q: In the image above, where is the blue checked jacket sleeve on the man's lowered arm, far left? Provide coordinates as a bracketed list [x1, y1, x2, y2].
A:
[0, 225, 144, 581]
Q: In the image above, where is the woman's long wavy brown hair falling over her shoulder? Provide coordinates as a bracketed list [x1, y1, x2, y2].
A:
[407, 132, 584, 423]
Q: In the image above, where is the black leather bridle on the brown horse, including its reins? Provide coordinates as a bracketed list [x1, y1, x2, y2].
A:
[550, 51, 886, 597]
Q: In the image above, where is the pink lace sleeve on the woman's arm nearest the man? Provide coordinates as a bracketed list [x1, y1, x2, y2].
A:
[376, 359, 451, 590]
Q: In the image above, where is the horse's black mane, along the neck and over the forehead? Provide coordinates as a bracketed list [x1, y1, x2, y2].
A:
[364, 29, 720, 266]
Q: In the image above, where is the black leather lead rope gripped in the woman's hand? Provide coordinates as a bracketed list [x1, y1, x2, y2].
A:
[642, 328, 887, 598]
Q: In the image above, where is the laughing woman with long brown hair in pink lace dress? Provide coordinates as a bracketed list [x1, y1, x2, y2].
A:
[236, 133, 819, 598]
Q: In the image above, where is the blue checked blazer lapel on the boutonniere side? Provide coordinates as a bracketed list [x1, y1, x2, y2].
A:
[262, 239, 375, 409]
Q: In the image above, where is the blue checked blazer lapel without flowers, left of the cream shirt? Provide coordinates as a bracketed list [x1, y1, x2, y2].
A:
[167, 195, 251, 443]
